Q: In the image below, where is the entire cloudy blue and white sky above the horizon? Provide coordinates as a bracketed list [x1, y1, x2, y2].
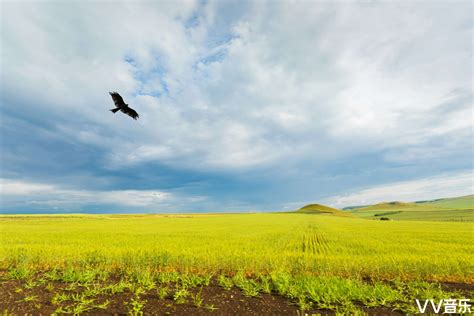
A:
[0, 0, 474, 213]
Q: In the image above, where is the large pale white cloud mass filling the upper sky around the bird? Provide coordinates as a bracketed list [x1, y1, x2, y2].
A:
[2, 2, 472, 173]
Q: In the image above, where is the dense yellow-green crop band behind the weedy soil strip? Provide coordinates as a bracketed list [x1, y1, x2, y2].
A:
[0, 213, 474, 283]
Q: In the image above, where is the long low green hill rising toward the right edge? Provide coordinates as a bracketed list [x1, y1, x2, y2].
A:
[348, 195, 474, 221]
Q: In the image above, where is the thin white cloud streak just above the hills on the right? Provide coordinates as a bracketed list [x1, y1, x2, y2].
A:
[324, 171, 474, 207]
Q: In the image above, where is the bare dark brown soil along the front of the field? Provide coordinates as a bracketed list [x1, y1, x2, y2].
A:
[0, 280, 414, 316]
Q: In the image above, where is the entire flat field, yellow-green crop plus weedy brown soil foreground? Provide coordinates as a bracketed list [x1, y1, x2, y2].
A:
[0, 213, 474, 315]
